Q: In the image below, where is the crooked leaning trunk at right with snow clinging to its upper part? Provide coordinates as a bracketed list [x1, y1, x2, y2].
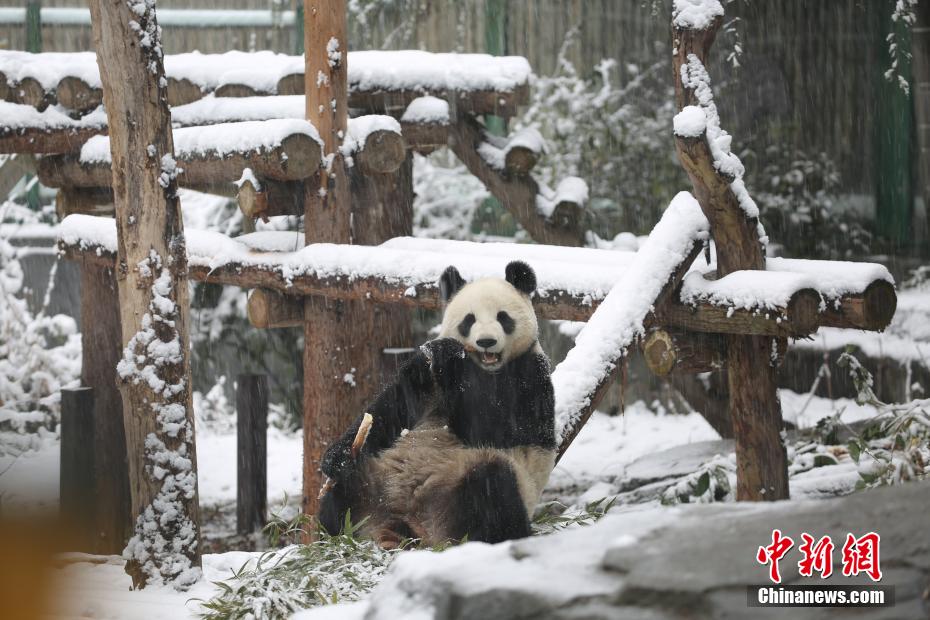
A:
[672, 0, 788, 501]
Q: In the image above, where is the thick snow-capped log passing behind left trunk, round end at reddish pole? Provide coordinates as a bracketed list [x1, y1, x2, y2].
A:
[39, 120, 322, 188]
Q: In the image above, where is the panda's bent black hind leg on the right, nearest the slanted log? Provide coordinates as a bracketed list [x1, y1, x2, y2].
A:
[448, 459, 530, 543]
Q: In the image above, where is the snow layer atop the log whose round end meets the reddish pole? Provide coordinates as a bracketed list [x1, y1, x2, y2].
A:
[81, 119, 322, 164]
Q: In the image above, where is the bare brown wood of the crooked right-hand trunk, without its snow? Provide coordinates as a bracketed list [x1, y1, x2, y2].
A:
[672, 12, 788, 501]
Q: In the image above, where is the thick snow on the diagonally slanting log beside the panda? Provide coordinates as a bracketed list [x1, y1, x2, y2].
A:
[552, 192, 710, 442]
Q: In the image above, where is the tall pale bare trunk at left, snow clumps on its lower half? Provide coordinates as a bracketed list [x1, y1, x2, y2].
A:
[90, 0, 200, 588]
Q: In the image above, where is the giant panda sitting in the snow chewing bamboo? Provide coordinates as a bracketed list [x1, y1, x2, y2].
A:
[318, 261, 556, 548]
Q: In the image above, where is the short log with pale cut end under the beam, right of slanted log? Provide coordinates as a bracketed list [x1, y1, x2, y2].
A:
[642, 329, 726, 377]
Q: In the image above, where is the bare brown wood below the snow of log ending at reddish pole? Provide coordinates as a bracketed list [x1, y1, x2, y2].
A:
[38, 134, 320, 189]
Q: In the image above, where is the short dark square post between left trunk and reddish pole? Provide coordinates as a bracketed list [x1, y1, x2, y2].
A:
[236, 374, 268, 534]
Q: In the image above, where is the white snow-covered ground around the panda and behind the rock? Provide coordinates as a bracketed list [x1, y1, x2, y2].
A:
[0, 390, 874, 620]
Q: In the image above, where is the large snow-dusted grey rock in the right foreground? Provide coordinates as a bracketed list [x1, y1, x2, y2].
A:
[301, 482, 930, 620]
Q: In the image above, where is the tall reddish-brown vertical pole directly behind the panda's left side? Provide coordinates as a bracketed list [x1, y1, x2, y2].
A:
[303, 0, 352, 515]
